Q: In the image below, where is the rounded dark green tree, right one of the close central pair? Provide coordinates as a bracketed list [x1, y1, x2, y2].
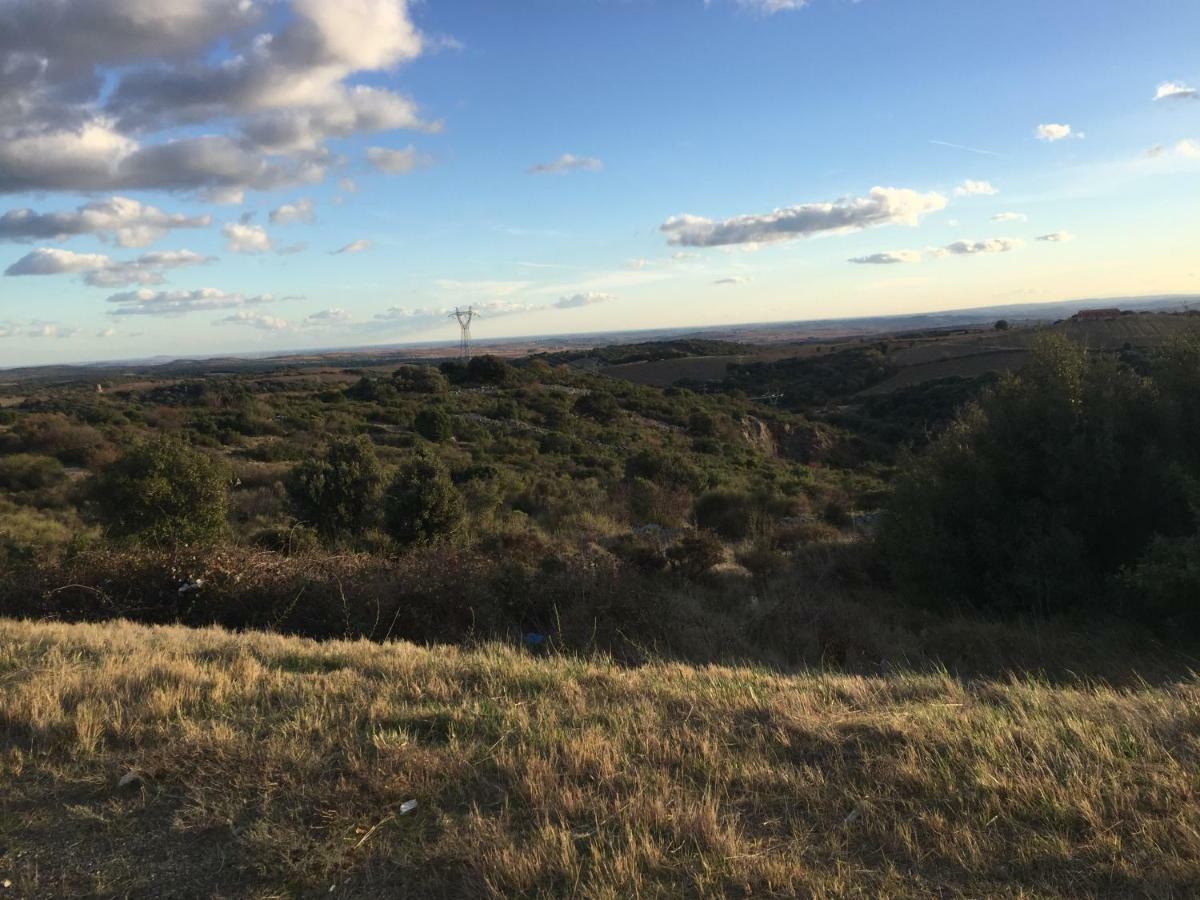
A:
[384, 454, 466, 545]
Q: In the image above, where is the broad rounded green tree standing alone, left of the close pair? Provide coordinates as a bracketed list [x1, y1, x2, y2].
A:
[91, 438, 229, 545]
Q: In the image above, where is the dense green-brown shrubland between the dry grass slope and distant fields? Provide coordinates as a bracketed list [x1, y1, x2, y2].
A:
[0, 340, 1200, 668]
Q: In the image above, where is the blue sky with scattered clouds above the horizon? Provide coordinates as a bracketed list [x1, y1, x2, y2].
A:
[0, 0, 1200, 367]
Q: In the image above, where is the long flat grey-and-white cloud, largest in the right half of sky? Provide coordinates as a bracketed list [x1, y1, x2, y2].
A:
[661, 187, 946, 247]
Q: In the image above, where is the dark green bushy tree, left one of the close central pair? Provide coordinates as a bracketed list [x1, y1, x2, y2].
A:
[288, 434, 383, 539]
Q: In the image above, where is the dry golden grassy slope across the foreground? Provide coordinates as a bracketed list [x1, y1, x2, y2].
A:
[0, 620, 1200, 898]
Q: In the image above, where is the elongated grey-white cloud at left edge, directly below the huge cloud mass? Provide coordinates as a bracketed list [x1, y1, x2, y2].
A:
[0, 197, 212, 247]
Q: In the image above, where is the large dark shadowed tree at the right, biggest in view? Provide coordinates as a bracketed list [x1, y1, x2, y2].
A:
[880, 336, 1195, 613]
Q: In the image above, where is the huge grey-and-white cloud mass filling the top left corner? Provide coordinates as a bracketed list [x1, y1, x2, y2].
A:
[0, 0, 438, 198]
